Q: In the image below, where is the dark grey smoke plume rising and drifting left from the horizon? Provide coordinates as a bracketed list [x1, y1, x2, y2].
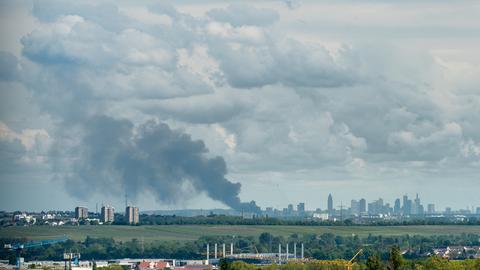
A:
[65, 116, 259, 212]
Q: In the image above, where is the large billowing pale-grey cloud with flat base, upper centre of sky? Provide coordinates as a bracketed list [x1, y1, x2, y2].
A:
[208, 23, 360, 88]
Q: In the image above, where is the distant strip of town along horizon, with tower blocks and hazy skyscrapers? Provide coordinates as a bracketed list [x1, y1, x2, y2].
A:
[0, 194, 480, 227]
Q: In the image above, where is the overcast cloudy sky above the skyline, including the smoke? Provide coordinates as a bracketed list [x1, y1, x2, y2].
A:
[0, 0, 480, 211]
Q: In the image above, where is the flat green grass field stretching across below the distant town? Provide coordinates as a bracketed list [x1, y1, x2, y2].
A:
[0, 225, 480, 242]
